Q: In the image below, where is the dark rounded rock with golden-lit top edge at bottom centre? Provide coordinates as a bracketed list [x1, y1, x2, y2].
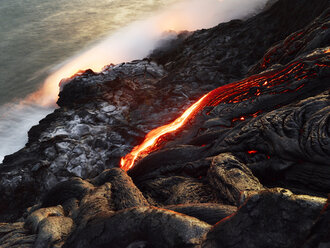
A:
[63, 207, 211, 248]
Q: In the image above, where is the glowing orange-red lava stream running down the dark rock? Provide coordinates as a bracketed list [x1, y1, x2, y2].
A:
[120, 51, 328, 171]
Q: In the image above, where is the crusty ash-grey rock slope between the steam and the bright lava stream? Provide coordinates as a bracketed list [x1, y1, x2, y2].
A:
[0, 61, 171, 221]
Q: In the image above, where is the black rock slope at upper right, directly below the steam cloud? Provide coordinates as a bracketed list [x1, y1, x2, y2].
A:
[150, 0, 329, 86]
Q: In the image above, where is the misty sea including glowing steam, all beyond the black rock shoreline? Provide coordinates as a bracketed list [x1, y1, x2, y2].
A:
[0, 0, 267, 163]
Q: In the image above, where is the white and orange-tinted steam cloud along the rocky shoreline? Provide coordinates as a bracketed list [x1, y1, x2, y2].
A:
[0, 0, 268, 162]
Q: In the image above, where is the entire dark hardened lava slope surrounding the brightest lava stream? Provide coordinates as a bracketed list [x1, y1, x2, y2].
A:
[0, 0, 330, 248]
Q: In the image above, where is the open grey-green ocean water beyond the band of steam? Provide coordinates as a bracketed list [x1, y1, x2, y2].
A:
[0, 0, 177, 105]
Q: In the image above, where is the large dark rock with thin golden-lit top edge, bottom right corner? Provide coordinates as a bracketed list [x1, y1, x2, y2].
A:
[202, 188, 326, 248]
